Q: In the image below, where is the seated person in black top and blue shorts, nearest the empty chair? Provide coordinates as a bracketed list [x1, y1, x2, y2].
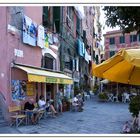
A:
[24, 99, 38, 124]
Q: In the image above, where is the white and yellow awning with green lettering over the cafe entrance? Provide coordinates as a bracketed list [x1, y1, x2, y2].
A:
[14, 64, 73, 84]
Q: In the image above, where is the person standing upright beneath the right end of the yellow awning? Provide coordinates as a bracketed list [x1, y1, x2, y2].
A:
[55, 88, 63, 114]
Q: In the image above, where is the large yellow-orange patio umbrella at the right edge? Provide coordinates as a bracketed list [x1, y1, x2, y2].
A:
[93, 49, 140, 85]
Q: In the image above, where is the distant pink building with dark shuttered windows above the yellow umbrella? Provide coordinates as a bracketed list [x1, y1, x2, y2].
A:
[104, 30, 140, 59]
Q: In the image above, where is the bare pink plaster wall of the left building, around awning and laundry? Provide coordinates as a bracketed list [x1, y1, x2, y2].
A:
[0, 7, 42, 119]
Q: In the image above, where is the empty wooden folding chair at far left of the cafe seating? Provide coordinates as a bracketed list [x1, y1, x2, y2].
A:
[8, 106, 27, 127]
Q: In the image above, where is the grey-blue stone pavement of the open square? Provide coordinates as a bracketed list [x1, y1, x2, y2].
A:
[0, 96, 131, 134]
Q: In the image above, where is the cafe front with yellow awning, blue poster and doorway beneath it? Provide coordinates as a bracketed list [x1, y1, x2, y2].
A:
[11, 64, 73, 107]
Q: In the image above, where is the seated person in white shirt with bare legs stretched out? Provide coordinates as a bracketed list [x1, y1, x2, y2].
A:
[38, 95, 57, 116]
